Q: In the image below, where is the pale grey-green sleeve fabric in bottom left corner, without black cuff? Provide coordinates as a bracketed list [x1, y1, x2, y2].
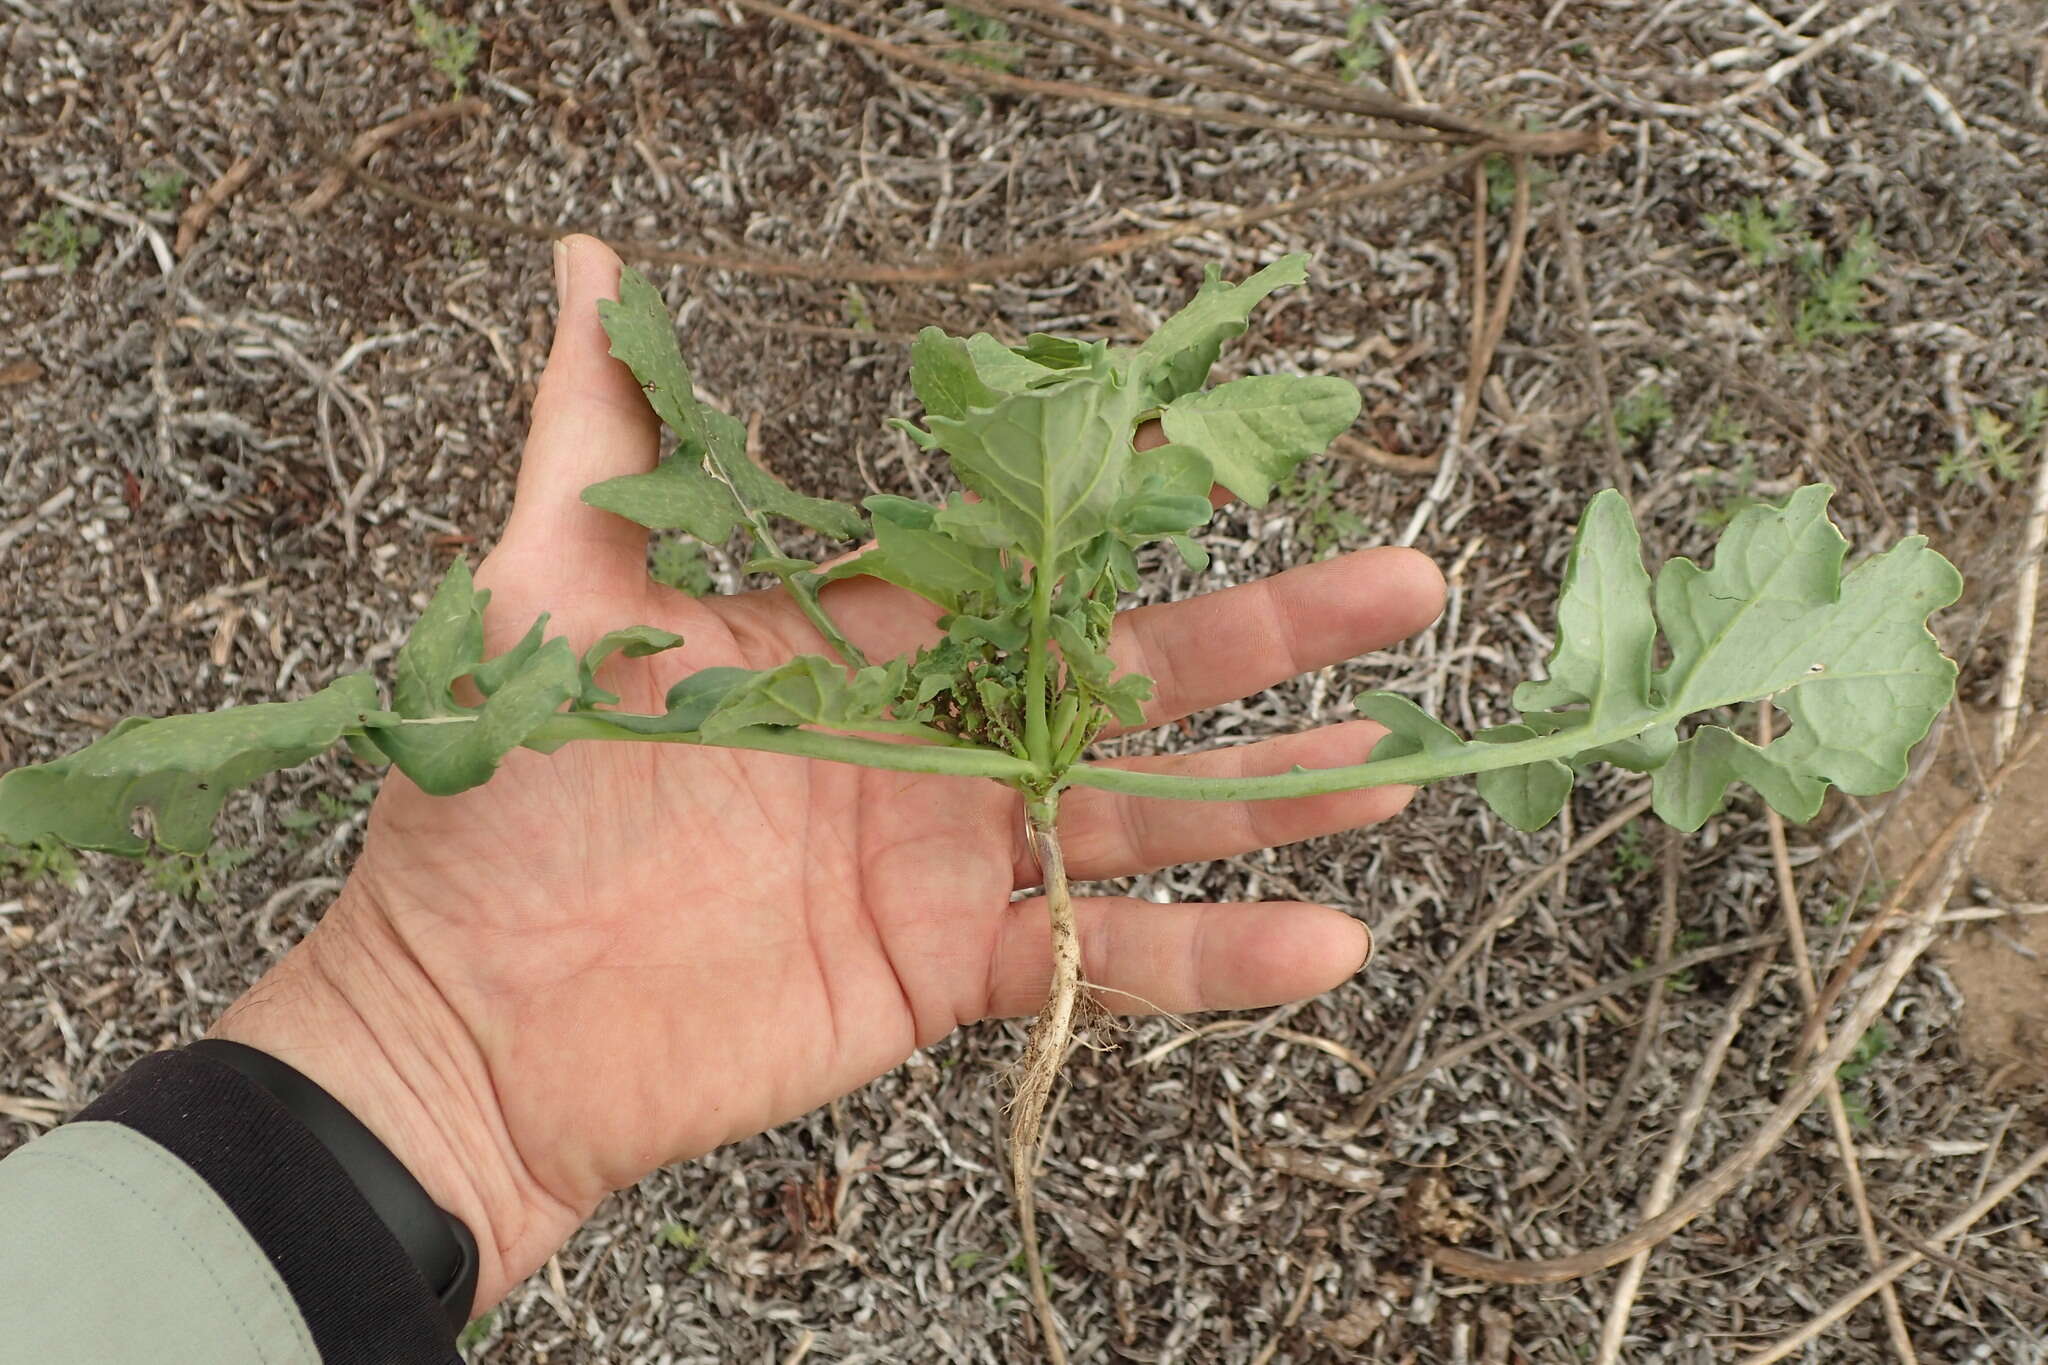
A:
[0, 1121, 319, 1365]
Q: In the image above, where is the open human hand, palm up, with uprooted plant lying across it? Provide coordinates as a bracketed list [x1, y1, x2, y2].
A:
[215, 237, 1442, 1312]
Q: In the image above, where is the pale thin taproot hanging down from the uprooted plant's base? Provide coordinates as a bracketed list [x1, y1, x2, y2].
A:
[1010, 792, 1081, 1365]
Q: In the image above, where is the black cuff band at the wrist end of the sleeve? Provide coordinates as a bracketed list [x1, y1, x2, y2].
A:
[78, 1052, 457, 1365]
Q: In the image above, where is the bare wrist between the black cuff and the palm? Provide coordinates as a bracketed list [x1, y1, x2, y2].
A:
[211, 884, 561, 1316]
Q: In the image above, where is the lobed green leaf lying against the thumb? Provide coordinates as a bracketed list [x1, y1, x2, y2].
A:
[584, 270, 866, 540]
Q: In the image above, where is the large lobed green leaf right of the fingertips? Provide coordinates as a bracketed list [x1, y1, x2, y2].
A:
[1358, 485, 1962, 829]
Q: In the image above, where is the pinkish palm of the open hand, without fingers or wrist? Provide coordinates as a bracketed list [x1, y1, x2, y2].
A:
[358, 565, 1042, 1203]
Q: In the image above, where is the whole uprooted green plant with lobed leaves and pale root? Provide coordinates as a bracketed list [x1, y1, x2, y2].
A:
[0, 256, 1962, 1359]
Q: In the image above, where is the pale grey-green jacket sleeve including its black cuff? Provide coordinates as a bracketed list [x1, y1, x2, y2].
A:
[0, 1052, 459, 1365]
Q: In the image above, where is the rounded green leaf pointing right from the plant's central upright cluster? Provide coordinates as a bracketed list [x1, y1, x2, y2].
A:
[1159, 375, 1360, 508]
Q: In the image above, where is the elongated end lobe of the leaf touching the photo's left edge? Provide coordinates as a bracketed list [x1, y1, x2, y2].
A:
[0, 673, 389, 855]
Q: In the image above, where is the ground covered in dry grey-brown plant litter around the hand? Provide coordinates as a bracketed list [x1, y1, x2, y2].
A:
[0, 0, 2048, 1365]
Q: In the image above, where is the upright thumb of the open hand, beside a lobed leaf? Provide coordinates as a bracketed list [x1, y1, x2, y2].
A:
[500, 235, 662, 587]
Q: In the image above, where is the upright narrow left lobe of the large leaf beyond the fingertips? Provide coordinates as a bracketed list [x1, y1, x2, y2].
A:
[1516, 489, 1657, 726]
